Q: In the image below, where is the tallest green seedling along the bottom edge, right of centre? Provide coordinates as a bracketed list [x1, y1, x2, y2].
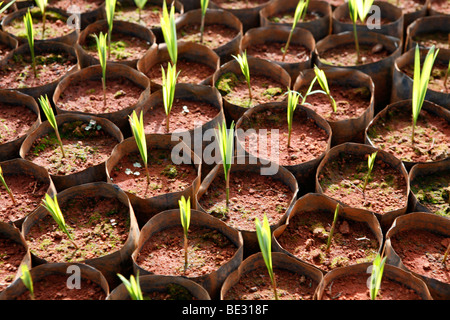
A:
[255, 215, 278, 300]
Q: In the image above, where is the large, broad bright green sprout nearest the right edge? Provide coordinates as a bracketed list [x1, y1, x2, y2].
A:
[411, 45, 439, 145]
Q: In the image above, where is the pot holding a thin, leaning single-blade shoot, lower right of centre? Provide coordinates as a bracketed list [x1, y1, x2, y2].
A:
[272, 193, 383, 274]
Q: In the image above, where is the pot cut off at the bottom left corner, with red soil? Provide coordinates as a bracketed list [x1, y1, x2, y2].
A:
[0, 262, 109, 300]
